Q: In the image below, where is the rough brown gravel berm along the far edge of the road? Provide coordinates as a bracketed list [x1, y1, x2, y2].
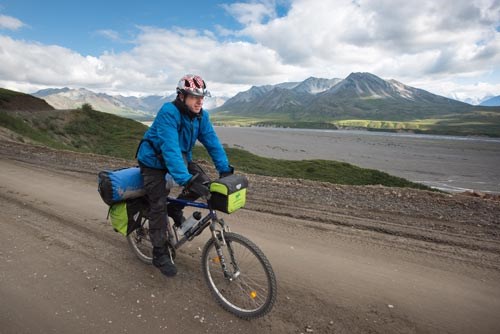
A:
[0, 140, 500, 268]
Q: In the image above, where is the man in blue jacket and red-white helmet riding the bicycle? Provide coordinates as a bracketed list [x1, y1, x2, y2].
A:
[137, 74, 233, 276]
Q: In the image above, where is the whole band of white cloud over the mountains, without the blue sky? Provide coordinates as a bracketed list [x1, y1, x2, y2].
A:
[0, 0, 500, 102]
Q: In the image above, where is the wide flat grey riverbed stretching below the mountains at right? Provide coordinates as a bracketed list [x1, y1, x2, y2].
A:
[216, 127, 500, 193]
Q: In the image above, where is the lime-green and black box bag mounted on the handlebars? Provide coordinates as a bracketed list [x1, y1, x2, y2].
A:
[210, 174, 248, 213]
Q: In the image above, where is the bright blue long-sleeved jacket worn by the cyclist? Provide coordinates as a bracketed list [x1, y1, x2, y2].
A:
[137, 102, 231, 186]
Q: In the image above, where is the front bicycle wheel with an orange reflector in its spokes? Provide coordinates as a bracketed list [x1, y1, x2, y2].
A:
[201, 232, 277, 319]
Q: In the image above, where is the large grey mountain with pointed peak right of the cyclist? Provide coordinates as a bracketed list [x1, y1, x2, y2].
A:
[213, 73, 482, 121]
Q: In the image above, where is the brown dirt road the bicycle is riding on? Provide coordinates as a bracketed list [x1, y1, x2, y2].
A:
[0, 143, 500, 334]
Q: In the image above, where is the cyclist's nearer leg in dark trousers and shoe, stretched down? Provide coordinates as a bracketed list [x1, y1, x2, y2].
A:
[141, 167, 177, 276]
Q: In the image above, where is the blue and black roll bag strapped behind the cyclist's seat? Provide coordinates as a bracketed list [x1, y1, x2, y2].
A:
[97, 167, 146, 205]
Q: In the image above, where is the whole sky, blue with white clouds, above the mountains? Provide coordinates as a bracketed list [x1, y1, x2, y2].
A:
[0, 0, 500, 103]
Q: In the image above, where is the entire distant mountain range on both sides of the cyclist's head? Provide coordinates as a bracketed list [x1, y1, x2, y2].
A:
[27, 73, 500, 122]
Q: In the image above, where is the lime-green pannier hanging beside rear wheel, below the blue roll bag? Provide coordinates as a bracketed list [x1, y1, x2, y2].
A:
[108, 197, 148, 236]
